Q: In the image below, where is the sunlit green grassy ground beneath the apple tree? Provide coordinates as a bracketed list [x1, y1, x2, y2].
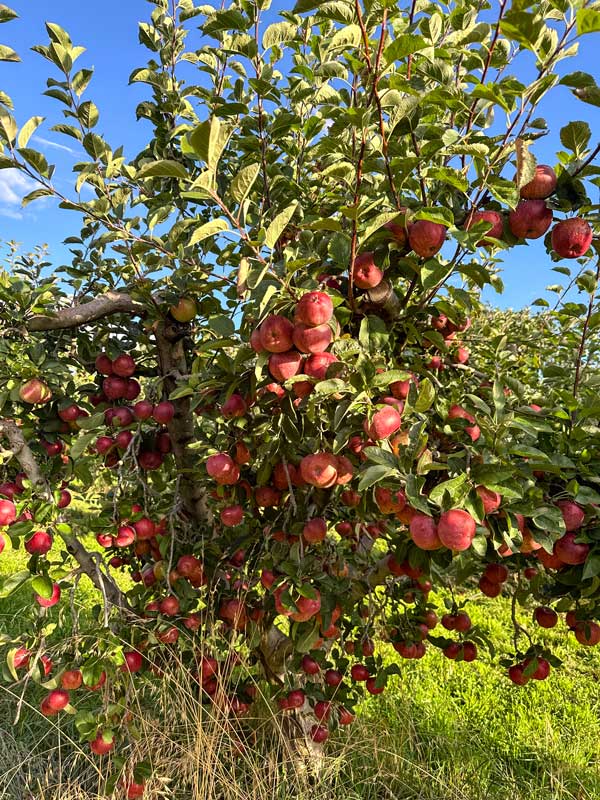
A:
[0, 540, 600, 800]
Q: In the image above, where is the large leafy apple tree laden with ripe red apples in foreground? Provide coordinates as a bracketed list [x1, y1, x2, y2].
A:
[0, 0, 600, 797]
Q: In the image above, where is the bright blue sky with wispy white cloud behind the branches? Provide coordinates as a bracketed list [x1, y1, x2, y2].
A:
[0, 0, 600, 308]
